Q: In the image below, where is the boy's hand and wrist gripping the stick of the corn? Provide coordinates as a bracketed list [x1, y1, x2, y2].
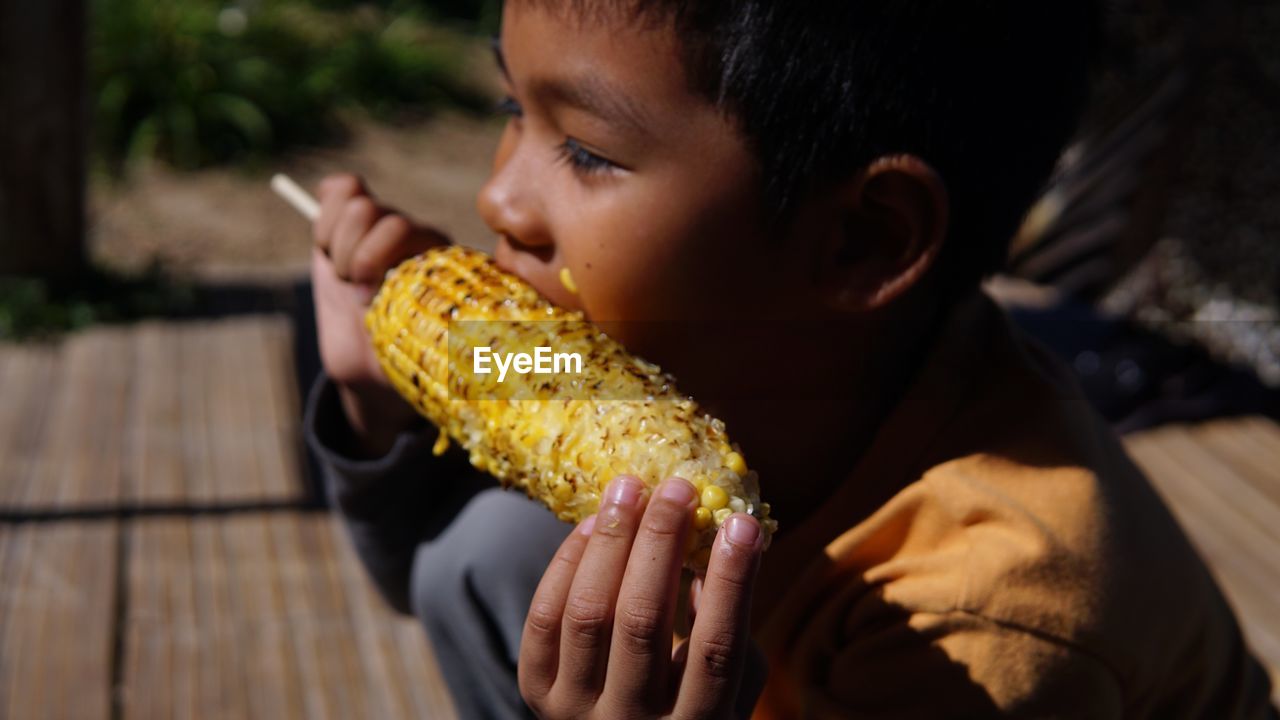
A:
[311, 174, 449, 456]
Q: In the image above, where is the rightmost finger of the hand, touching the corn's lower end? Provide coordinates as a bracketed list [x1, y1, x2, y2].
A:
[675, 512, 762, 717]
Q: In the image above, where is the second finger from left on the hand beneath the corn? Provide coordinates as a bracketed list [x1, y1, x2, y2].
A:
[556, 475, 645, 705]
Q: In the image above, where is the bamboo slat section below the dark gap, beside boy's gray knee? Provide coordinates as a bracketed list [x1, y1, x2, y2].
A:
[122, 512, 453, 720]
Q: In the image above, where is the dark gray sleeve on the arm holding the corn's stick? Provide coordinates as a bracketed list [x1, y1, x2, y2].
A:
[303, 374, 497, 614]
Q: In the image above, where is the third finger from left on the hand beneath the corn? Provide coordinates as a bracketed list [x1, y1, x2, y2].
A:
[604, 478, 698, 711]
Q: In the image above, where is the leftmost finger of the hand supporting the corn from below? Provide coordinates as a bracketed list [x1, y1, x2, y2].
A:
[516, 515, 595, 705]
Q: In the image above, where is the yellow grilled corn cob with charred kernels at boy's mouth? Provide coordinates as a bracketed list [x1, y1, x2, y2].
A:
[365, 246, 777, 571]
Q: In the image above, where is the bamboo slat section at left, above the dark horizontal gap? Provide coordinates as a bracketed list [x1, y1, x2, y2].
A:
[0, 315, 305, 514]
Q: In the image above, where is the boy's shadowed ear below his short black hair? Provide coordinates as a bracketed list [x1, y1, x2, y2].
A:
[818, 155, 948, 313]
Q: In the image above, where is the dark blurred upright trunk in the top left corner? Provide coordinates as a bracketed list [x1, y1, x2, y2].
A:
[0, 0, 87, 278]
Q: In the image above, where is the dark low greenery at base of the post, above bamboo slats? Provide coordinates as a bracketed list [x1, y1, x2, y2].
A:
[0, 264, 197, 340]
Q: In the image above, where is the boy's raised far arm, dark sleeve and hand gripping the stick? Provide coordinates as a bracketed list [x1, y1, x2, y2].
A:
[306, 169, 476, 612]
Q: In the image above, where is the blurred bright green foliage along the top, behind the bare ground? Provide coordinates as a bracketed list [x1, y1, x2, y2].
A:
[90, 0, 492, 174]
